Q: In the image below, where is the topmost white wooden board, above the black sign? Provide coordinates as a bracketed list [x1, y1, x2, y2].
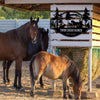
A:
[51, 5, 93, 11]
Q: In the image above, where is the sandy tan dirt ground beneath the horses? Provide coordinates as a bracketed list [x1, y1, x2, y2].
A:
[0, 62, 100, 100]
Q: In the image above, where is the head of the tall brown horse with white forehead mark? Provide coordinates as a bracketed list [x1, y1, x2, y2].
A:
[30, 17, 39, 44]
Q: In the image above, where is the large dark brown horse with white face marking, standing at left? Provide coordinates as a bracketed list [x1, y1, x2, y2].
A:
[0, 18, 39, 89]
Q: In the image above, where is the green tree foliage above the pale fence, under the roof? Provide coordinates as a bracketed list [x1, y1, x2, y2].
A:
[0, 6, 50, 19]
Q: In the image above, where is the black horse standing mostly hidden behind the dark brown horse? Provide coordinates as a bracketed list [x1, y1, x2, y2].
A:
[3, 28, 49, 87]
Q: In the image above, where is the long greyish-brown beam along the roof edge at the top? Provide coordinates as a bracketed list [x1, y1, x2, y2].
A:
[5, 0, 100, 4]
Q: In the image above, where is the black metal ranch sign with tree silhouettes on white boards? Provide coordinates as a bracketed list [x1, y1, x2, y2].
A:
[50, 8, 92, 37]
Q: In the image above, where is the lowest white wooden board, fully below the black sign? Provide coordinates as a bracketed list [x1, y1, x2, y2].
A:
[50, 41, 92, 47]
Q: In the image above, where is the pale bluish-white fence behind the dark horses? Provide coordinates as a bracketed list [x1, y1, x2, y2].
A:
[0, 19, 50, 32]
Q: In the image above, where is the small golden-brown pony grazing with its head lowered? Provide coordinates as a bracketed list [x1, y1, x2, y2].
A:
[30, 51, 83, 99]
